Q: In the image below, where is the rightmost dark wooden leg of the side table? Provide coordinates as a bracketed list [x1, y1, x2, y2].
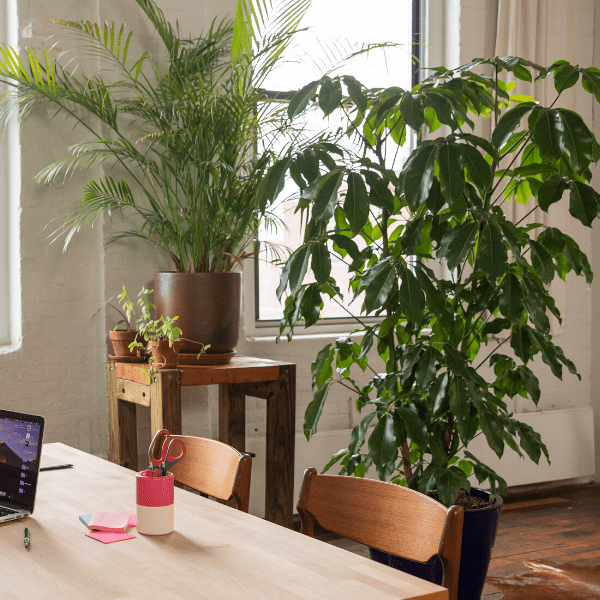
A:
[265, 365, 296, 528]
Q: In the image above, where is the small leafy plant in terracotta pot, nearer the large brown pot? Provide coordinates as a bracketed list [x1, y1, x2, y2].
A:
[129, 287, 209, 369]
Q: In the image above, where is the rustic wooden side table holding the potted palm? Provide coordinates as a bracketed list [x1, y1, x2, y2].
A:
[106, 356, 296, 528]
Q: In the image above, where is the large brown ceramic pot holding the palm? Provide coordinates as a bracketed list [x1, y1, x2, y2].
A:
[154, 272, 242, 354]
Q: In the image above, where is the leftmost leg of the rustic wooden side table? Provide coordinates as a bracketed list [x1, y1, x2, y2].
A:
[106, 363, 138, 469]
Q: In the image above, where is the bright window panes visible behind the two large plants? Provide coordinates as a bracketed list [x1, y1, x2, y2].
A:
[254, 0, 420, 331]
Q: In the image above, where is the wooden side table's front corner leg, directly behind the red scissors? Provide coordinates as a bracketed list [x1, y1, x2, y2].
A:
[150, 369, 181, 437]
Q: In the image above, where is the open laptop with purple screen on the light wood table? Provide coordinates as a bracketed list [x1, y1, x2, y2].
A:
[0, 410, 44, 523]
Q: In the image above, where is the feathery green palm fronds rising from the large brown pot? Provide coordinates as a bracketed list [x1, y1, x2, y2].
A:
[0, 0, 310, 271]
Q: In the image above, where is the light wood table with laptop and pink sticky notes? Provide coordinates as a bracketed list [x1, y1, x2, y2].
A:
[0, 444, 448, 600]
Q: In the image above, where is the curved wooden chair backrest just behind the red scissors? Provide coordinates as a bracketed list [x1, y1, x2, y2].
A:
[171, 435, 252, 512]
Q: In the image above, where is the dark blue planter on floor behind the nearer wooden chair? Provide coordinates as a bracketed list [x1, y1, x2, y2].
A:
[369, 488, 502, 600]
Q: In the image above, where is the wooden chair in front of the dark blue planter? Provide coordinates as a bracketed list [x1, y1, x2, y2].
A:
[298, 468, 463, 600]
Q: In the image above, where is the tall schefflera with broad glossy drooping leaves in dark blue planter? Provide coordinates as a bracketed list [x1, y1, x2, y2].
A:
[259, 57, 600, 506]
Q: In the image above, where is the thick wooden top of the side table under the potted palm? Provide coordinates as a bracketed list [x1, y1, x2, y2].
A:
[115, 356, 292, 385]
